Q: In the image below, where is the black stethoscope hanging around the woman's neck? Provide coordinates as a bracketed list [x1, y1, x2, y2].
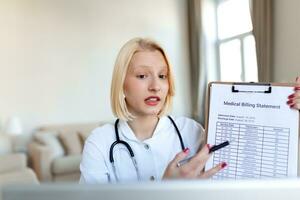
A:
[109, 116, 185, 182]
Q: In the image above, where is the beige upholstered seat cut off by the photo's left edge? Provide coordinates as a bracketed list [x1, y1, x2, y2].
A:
[0, 153, 38, 185]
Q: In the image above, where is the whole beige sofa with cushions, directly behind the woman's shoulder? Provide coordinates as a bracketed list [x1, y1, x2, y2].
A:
[28, 123, 103, 182]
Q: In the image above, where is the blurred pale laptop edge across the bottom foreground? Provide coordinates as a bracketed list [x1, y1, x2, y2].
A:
[2, 179, 300, 200]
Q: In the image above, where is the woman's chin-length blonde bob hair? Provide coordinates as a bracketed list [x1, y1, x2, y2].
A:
[110, 38, 175, 121]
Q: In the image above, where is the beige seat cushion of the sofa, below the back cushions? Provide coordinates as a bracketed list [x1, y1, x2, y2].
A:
[52, 155, 81, 175]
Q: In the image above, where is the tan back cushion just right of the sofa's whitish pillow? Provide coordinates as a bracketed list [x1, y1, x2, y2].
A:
[58, 132, 82, 155]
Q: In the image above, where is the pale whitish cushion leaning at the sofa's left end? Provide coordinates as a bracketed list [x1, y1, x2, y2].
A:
[34, 131, 65, 157]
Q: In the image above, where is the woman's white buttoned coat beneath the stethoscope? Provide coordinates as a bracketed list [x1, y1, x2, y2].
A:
[80, 116, 204, 183]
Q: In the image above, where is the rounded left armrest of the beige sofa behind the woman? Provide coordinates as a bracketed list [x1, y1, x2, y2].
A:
[28, 142, 53, 182]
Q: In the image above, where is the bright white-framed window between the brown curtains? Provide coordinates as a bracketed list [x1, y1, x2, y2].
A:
[216, 0, 258, 81]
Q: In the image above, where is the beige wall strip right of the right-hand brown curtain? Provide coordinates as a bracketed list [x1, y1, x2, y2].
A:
[273, 0, 300, 82]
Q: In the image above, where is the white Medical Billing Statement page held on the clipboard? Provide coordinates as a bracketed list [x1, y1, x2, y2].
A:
[206, 83, 299, 179]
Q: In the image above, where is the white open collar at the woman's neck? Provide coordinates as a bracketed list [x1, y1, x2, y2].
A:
[119, 116, 171, 142]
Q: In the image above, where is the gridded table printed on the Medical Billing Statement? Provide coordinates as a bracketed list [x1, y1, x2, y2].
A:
[213, 122, 290, 179]
